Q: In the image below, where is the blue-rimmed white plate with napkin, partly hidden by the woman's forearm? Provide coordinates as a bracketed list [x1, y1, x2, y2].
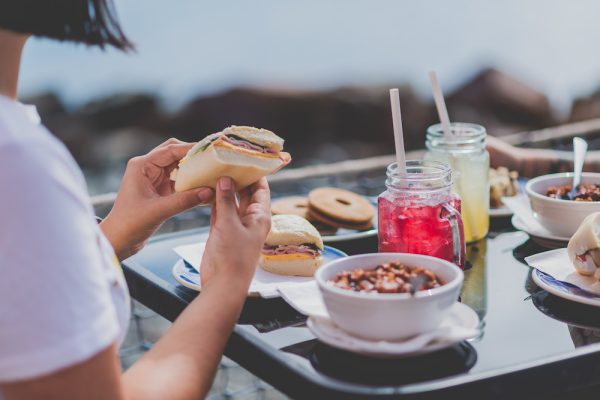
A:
[171, 246, 348, 299]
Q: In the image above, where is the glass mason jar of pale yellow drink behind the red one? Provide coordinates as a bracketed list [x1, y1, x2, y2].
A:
[425, 122, 490, 242]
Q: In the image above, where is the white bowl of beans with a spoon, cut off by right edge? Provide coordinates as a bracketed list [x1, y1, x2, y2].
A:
[525, 172, 600, 238]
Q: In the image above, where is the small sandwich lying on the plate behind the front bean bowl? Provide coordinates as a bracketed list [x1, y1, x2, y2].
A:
[260, 214, 323, 276]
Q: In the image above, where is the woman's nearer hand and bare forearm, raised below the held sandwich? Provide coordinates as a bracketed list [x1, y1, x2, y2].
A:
[124, 178, 271, 400]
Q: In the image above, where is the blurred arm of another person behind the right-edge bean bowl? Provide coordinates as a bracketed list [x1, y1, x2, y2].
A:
[486, 135, 600, 178]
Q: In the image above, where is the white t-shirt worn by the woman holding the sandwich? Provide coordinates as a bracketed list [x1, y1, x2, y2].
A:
[0, 96, 130, 390]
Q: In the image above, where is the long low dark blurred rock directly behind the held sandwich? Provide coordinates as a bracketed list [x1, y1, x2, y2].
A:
[162, 87, 432, 166]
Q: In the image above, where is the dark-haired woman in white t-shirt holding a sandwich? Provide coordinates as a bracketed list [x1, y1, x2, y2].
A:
[0, 0, 270, 400]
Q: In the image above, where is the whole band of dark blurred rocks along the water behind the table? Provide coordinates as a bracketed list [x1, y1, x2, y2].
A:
[24, 69, 600, 194]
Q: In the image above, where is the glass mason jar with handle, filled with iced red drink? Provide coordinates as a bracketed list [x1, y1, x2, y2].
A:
[377, 160, 465, 269]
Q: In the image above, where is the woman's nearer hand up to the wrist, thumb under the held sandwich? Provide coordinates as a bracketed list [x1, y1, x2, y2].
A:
[200, 177, 271, 294]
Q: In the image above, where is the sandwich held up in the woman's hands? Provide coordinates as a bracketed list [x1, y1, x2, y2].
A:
[171, 126, 291, 192]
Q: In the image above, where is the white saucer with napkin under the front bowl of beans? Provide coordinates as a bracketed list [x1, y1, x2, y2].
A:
[306, 302, 480, 358]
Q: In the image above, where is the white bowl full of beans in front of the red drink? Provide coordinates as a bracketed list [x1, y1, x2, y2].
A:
[315, 253, 463, 341]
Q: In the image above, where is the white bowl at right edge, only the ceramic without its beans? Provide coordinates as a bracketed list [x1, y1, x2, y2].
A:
[525, 172, 600, 238]
